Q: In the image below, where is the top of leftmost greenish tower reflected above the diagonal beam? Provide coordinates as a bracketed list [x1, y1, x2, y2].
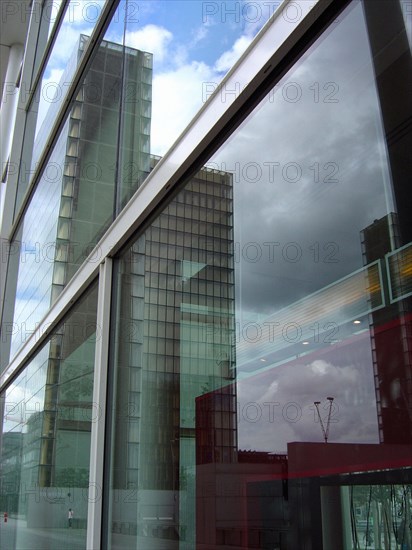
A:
[50, 35, 152, 300]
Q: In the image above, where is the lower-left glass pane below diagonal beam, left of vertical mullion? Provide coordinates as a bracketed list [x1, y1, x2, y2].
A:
[0, 285, 97, 550]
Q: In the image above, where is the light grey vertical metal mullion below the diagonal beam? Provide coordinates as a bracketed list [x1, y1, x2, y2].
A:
[86, 258, 113, 550]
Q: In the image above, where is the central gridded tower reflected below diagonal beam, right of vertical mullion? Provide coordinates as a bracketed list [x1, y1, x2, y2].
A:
[113, 159, 236, 543]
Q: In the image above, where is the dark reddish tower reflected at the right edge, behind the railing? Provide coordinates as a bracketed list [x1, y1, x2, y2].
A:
[362, 213, 412, 444]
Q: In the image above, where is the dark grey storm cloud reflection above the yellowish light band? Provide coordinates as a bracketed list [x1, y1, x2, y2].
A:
[212, 2, 393, 313]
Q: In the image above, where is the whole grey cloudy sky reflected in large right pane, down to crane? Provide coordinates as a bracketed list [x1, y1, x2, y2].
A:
[205, 4, 394, 452]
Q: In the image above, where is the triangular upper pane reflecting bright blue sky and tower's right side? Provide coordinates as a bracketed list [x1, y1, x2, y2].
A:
[108, 0, 284, 211]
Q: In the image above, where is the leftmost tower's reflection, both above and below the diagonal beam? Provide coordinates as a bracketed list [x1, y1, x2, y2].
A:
[20, 35, 151, 487]
